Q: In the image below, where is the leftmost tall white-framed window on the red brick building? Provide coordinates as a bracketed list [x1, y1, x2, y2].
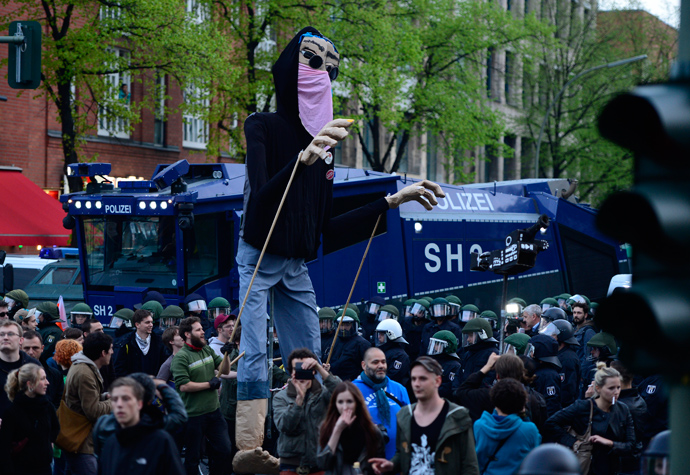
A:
[98, 48, 132, 139]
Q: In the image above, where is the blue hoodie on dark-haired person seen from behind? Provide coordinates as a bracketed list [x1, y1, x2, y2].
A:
[474, 411, 541, 475]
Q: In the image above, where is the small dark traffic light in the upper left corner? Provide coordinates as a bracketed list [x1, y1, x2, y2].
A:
[7, 21, 41, 89]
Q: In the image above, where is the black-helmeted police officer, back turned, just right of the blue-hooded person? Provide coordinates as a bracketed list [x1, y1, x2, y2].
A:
[530, 335, 563, 417]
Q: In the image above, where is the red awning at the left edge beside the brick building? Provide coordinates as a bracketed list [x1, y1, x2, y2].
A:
[0, 169, 71, 246]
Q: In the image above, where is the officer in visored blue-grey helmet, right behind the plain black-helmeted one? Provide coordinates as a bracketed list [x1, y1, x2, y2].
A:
[542, 320, 580, 407]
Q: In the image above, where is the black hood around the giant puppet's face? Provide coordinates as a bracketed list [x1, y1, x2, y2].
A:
[271, 26, 321, 133]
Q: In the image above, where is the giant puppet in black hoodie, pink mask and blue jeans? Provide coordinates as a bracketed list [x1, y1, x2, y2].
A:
[233, 27, 444, 473]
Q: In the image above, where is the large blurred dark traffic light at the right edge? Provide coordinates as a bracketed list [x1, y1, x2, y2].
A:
[595, 83, 690, 376]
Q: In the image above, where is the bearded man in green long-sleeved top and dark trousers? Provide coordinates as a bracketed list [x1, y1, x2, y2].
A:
[171, 317, 232, 475]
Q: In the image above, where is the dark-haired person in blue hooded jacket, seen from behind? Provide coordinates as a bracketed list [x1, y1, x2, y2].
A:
[474, 378, 541, 475]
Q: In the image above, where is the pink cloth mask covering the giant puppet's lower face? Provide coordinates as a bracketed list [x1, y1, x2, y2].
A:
[297, 63, 333, 137]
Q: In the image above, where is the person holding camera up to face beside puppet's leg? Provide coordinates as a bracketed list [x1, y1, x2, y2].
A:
[272, 348, 341, 475]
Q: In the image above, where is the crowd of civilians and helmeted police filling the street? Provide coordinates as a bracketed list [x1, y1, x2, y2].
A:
[0, 289, 670, 475]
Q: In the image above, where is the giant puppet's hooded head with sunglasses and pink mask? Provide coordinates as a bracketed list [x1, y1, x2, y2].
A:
[272, 26, 339, 137]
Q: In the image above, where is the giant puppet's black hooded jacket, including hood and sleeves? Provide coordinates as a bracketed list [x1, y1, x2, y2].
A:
[241, 27, 389, 259]
